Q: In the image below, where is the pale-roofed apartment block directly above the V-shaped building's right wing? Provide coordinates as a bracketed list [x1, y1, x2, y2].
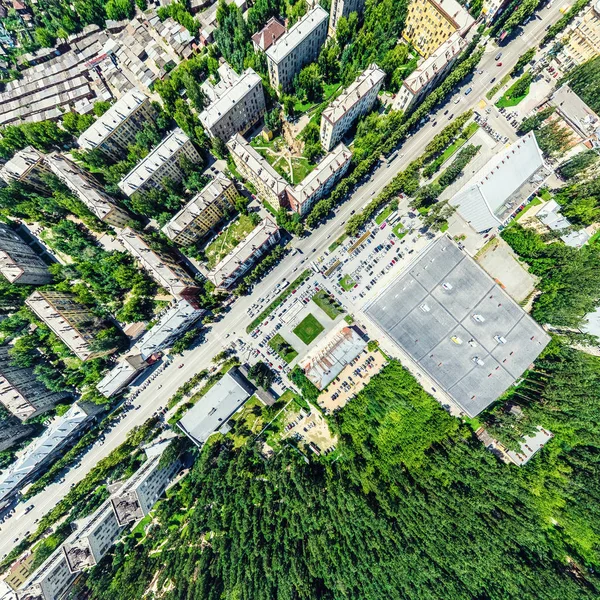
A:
[321, 64, 385, 152]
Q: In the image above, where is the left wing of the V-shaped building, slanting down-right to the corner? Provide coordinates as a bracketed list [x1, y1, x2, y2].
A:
[227, 134, 288, 209]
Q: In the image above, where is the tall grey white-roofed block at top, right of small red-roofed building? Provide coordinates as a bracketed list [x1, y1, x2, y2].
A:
[266, 6, 329, 92]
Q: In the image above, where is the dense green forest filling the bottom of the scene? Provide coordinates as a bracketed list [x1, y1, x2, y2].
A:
[79, 359, 600, 600]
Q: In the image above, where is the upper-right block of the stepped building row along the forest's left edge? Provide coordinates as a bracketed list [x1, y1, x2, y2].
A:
[110, 440, 181, 526]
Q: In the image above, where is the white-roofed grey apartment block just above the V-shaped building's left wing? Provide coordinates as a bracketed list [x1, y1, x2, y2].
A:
[200, 69, 266, 142]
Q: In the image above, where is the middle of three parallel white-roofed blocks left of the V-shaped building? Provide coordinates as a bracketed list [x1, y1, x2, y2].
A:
[119, 127, 200, 196]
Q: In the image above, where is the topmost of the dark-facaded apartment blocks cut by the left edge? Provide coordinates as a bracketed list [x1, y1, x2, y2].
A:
[0, 223, 52, 285]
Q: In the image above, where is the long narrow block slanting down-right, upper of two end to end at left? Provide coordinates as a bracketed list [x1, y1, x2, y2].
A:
[45, 152, 130, 227]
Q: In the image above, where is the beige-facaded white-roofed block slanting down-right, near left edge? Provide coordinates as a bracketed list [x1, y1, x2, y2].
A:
[25, 290, 115, 360]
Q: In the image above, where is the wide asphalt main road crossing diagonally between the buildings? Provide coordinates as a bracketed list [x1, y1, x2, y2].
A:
[0, 3, 562, 558]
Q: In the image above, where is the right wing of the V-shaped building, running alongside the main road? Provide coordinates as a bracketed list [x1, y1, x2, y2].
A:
[287, 144, 352, 215]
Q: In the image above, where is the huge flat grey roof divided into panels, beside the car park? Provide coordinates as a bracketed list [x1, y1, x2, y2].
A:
[366, 237, 550, 416]
